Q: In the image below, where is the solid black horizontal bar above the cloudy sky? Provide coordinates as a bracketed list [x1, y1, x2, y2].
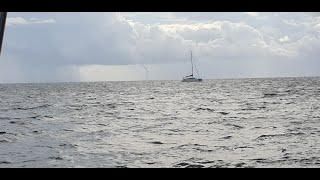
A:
[0, 0, 320, 12]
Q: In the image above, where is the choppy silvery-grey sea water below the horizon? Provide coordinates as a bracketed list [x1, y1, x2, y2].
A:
[0, 77, 320, 168]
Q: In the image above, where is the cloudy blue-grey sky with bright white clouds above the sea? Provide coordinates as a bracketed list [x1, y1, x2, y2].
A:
[0, 12, 320, 83]
